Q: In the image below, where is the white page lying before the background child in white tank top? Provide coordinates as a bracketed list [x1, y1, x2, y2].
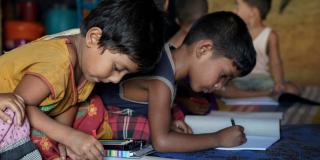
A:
[222, 97, 279, 106]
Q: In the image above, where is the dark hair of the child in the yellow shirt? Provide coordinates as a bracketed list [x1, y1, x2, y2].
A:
[80, 0, 164, 71]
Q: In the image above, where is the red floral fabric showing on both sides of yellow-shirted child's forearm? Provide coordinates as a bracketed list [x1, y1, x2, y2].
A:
[31, 97, 112, 160]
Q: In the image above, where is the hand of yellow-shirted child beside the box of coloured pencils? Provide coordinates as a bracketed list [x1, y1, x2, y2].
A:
[67, 130, 104, 160]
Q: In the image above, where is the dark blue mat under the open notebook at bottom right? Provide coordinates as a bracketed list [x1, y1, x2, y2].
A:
[152, 125, 320, 160]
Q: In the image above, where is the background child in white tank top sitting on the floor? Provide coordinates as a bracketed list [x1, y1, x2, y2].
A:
[216, 0, 299, 97]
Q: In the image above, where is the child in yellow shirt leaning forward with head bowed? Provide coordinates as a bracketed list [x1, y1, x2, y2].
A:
[0, 0, 163, 159]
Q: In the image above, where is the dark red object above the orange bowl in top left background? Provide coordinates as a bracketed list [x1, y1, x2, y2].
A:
[17, 0, 38, 21]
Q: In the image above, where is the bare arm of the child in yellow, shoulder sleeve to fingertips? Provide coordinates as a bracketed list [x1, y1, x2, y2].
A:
[15, 75, 104, 159]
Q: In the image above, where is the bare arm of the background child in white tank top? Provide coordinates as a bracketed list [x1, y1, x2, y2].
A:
[267, 31, 284, 92]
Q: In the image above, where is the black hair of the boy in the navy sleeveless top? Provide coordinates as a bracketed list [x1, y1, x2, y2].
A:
[184, 11, 256, 76]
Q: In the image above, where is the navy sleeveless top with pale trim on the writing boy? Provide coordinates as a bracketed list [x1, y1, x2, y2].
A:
[96, 44, 176, 116]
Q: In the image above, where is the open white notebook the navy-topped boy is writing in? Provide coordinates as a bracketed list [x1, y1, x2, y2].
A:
[185, 111, 282, 150]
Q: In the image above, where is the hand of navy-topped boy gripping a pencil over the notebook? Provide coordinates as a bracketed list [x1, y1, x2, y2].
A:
[217, 125, 247, 147]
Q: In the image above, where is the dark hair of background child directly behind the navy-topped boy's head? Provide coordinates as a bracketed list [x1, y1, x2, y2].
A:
[175, 0, 208, 24]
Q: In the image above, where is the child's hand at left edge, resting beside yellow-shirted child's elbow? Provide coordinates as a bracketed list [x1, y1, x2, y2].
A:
[0, 93, 25, 125]
